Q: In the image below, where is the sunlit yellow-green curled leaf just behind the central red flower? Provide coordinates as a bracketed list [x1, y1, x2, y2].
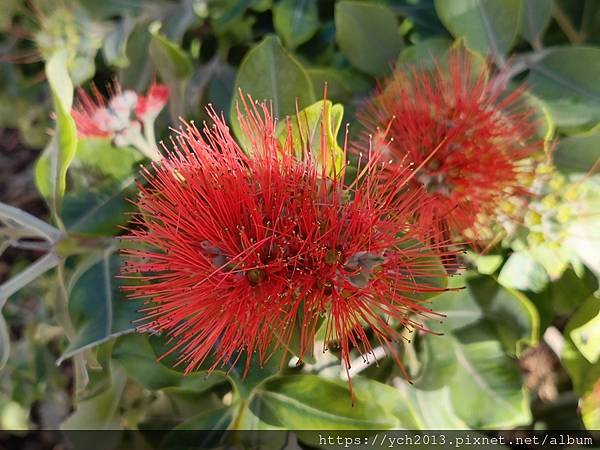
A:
[276, 100, 344, 177]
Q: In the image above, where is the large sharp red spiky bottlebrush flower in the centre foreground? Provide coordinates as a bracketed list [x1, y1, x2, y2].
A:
[123, 97, 460, 386]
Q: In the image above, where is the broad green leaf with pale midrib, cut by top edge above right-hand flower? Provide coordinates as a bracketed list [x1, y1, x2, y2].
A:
[435, 0, 522, 59]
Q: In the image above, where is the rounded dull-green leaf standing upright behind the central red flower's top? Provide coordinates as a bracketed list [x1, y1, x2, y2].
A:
[230, 36, 315, 147]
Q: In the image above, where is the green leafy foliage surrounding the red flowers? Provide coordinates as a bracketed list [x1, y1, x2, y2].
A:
[0, 0, 600, 440]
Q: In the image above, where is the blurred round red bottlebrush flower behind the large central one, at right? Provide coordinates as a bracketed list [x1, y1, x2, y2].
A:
[360, 51, 542, 246]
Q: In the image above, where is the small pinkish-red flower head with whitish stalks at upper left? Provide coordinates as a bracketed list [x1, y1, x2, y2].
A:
[71, 83, 169, 160]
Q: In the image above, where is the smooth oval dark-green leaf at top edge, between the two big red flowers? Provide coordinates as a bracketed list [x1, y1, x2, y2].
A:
[335, 1, 403, 75]
